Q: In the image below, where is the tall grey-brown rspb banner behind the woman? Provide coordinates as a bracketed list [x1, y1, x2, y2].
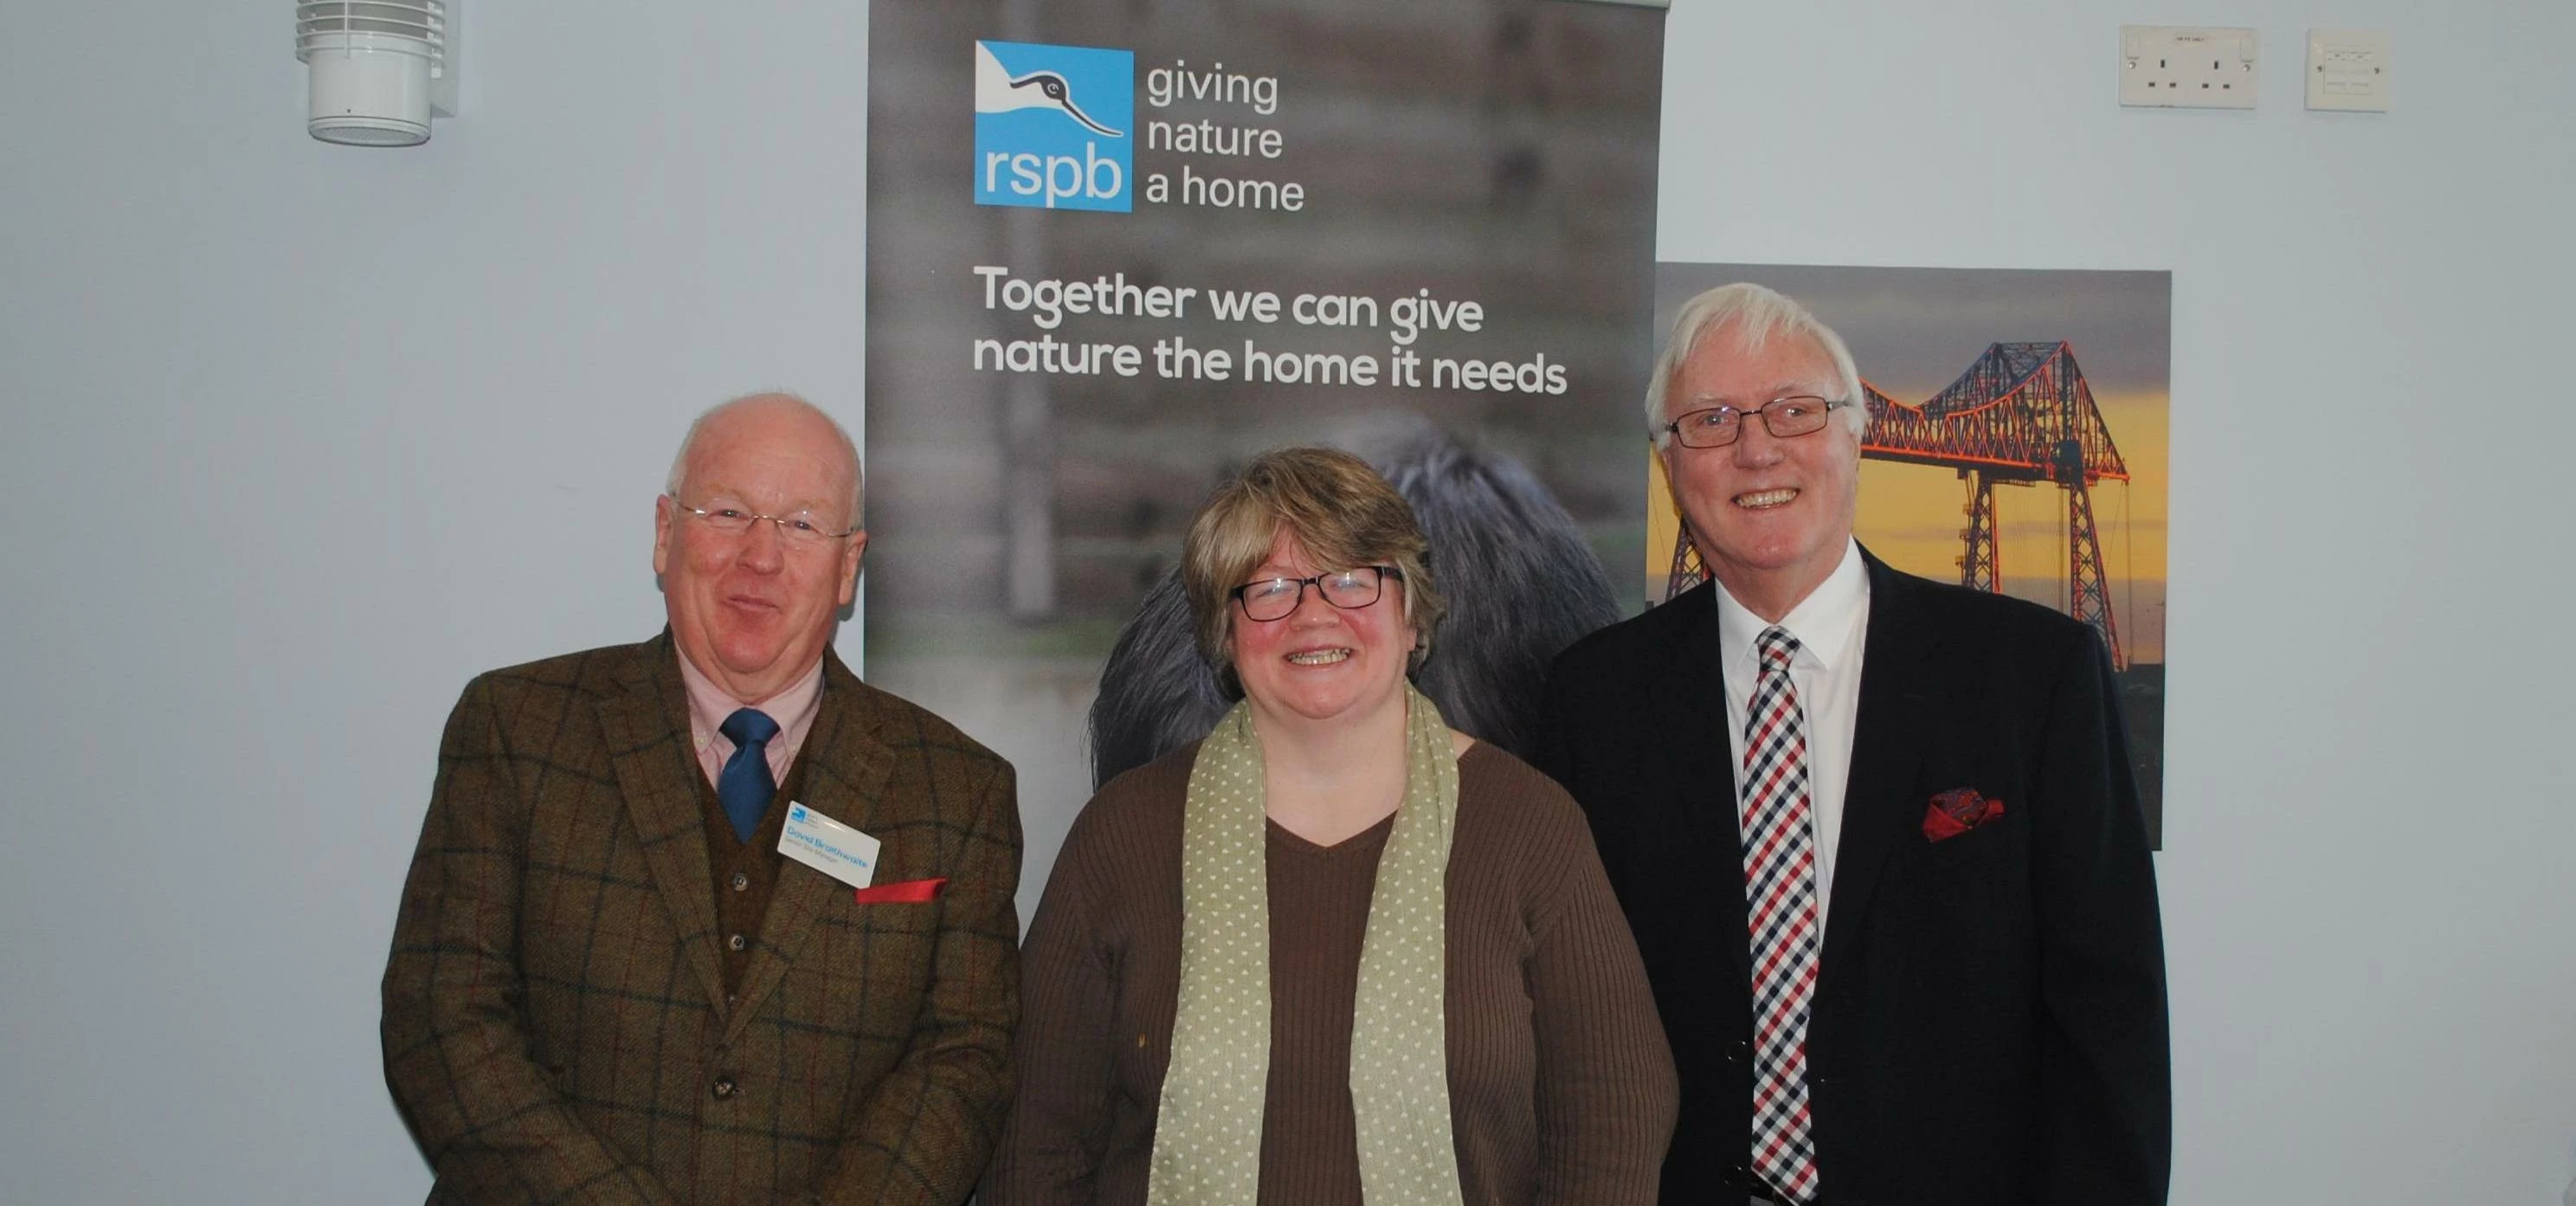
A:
[863, 0, 1664, 905]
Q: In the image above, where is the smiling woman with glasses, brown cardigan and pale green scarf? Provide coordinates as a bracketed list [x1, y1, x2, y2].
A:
[982, 448, 1674, 1206]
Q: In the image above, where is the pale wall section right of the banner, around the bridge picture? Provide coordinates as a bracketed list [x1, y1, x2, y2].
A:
[1659, 0, 2576, 1203]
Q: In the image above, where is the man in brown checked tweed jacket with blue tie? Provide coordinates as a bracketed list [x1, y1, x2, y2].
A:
[383, 394, 1020, 1206]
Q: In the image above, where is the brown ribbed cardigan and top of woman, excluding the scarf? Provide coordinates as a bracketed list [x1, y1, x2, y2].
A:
[982, 745, 1677, 1206]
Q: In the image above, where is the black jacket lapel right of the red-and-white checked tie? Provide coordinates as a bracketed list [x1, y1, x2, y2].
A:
[1816, 549, 1940, 995]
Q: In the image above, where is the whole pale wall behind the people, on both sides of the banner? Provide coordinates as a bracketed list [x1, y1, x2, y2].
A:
[0, 0, 2576, 1206]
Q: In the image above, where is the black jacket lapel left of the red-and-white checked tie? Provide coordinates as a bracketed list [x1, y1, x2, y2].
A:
[1652, 580, 1752, 974]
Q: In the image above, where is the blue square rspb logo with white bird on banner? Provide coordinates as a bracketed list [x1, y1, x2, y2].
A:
[974, 42, 1136, 214]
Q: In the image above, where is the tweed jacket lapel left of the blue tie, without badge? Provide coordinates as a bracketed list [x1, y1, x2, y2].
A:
[597, 636, 724, 1016]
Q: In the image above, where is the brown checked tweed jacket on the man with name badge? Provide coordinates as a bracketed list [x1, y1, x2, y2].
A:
[383, 631, 1020, 1206]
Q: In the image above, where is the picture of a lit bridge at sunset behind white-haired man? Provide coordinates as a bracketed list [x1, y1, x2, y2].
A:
[1644, 263, 2174, 848]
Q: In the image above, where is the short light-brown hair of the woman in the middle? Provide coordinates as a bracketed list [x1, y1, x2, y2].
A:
[1180, 448, 1443, 696]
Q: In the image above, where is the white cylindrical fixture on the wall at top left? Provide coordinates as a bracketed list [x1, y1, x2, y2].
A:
[296, 0, 456, 147]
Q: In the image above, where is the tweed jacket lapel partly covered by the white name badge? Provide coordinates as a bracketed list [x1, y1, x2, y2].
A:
[721, 649, 894, 1042]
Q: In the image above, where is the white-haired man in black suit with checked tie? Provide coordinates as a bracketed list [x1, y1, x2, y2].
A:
[1543, 283, 2172, 1206]
